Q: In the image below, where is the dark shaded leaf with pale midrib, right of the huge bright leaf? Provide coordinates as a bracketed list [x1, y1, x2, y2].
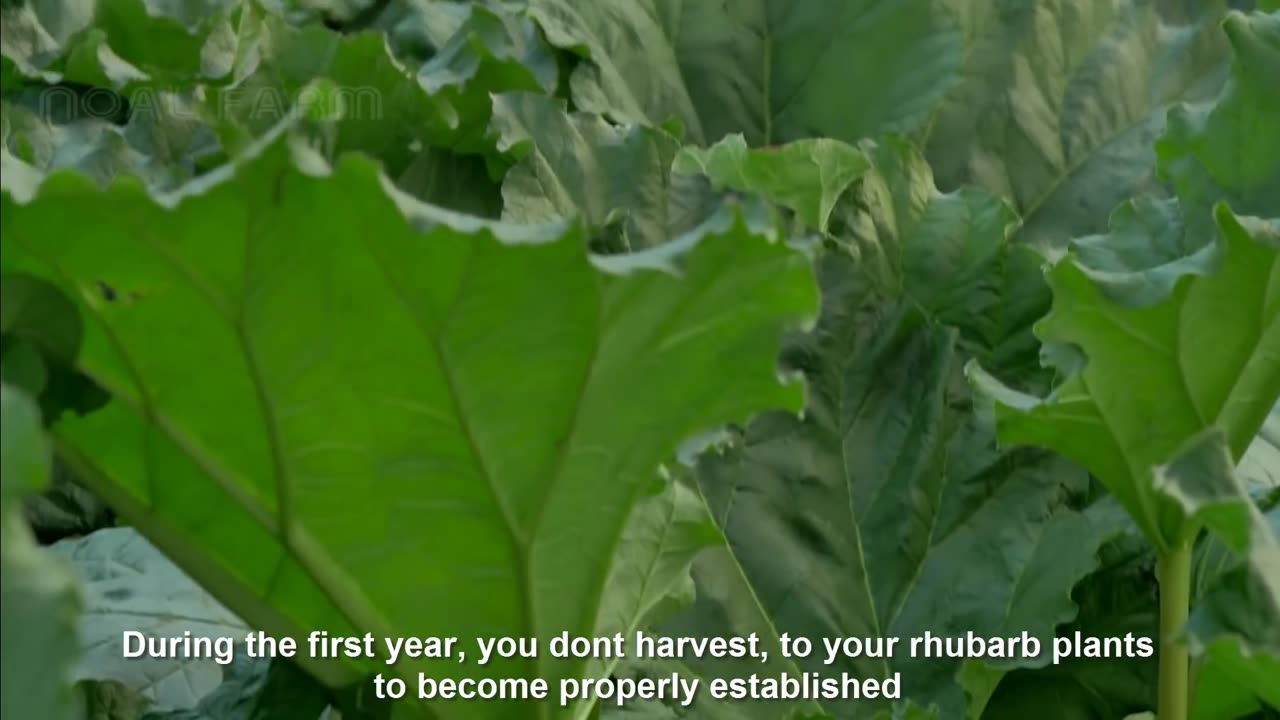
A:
[700, 248, 1119, 717]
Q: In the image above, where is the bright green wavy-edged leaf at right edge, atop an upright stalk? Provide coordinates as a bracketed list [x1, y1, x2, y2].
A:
[974, 206, 1280, 548]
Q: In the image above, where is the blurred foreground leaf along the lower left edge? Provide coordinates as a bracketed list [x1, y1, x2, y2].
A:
[0, 384, 79, 720]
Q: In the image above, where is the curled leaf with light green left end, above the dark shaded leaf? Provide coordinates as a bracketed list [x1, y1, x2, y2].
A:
[675, 136, 1048, 360]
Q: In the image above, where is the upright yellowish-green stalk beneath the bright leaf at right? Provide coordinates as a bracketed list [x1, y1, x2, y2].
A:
[1156, 543, 1192, 720]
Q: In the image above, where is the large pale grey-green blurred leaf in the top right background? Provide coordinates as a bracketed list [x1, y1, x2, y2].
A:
[928, 0, 1225, 245]
